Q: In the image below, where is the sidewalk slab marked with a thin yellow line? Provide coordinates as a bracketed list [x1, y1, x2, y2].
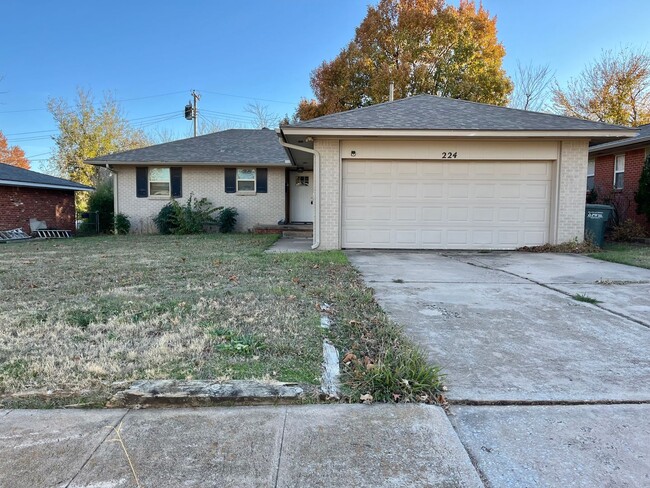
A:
[71, 407, 286, 488]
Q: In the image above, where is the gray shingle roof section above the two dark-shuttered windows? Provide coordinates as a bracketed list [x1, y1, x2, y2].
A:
[86, 129, 288, 166]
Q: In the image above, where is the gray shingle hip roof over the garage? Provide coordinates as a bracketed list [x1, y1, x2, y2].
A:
[283, 95, 629, 131]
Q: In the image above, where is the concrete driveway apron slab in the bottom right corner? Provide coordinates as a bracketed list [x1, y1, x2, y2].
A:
[452, 405, 650, 488]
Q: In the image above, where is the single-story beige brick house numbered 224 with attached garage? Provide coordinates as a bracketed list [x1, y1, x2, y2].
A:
[88, 95, 636, 249]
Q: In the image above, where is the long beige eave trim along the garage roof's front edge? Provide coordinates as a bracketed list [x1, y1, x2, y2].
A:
[281, 127, 637, 140]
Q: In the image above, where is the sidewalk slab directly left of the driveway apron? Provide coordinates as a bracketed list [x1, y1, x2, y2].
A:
[277, 405, 483, 488]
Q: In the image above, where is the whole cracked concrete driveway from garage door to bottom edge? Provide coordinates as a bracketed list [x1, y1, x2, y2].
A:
[348, 251, 650, 486]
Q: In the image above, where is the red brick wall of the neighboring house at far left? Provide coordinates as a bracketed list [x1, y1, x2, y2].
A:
[0, 186, 75, 234]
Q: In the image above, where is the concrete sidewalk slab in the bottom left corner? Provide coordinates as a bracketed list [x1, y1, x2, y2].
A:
[0, 410, 126, 488]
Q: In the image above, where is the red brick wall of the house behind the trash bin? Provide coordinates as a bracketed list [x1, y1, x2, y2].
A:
[594, 148, 650, 230]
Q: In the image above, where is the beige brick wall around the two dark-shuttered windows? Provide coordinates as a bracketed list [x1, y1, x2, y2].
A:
[116, 166, 285, 233]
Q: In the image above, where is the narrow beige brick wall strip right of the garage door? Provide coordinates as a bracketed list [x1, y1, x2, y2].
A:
[556, 140, 589, 244]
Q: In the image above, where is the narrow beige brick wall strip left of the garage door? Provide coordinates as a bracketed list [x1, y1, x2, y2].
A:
[314, 139, 341, 250]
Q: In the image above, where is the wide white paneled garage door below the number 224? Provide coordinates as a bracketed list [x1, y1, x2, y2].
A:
[342, 160, 552, 249]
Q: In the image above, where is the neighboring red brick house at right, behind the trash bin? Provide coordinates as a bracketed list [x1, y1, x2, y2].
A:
[587, 124, 650, 229]
